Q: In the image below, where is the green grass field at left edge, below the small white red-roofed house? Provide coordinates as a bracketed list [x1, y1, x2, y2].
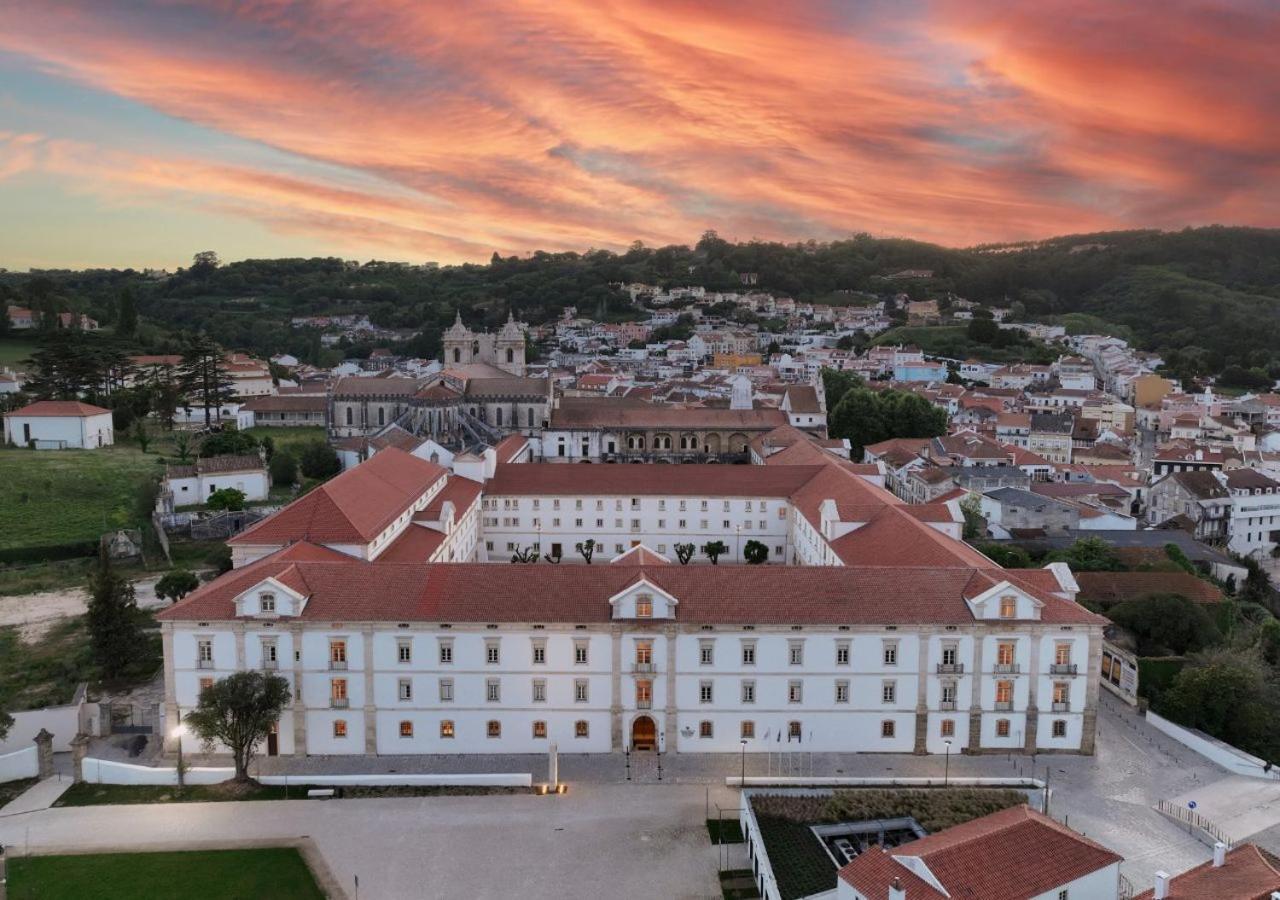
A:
[0, 446, 164, 550]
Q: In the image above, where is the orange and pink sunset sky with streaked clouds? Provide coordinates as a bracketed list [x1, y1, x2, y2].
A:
[0, 0, 1280, 269]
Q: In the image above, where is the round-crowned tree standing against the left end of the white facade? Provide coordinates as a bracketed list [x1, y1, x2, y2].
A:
[183, 672, 293, 782]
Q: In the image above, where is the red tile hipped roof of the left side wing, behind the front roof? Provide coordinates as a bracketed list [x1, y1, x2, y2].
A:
[227, 447, 445, 545]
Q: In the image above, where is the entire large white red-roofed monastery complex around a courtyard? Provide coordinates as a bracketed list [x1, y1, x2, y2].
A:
[159, 425, 1105, 755]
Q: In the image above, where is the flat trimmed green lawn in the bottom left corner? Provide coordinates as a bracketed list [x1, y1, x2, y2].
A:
[8, 848, 324, 900]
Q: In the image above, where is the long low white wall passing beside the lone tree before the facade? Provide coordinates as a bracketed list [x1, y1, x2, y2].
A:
[78, 748, 534, 787]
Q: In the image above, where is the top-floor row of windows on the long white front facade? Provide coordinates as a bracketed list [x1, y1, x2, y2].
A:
[196, 637, 1071, 673]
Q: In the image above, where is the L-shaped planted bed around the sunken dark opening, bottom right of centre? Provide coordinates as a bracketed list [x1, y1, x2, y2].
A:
[751, 787, 1027, 900]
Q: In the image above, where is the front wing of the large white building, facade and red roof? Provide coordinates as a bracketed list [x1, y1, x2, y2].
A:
[159, 543, 1105, 755]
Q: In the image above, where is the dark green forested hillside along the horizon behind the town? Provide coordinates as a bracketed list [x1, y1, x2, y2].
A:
[0, 227, 1280, 376]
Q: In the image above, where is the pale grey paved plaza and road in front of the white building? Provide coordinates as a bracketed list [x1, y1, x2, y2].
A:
[0, 695, 1280, 899]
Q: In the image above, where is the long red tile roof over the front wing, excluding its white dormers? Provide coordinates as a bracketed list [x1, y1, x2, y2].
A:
[160, 560, 1106, 625]
